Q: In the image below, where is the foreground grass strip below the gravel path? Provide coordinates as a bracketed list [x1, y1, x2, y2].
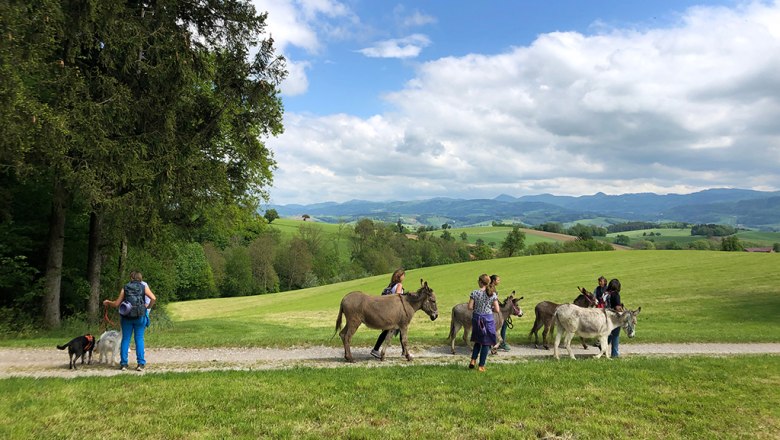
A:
[0, 356, 780, 439]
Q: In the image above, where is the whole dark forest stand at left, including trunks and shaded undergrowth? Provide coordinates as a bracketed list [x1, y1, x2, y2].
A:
[0, 0, 286, 327]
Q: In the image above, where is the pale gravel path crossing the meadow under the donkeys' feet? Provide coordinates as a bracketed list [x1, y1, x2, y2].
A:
[0, 343, 780, 379]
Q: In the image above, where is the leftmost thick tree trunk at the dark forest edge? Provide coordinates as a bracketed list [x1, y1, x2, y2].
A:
[43, 178, 65, 328]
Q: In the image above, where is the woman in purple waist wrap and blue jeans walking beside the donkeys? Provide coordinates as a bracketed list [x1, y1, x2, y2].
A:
[468, 273, 501, 371]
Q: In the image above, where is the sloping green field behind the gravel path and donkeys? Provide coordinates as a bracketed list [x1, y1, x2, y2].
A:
[0, 251, 780, 347]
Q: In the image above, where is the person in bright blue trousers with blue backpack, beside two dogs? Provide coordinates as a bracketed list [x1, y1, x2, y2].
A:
[103, 272, 157, 371]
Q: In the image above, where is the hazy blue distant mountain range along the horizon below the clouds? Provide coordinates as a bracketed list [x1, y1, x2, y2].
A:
[268, 189, 780, 230]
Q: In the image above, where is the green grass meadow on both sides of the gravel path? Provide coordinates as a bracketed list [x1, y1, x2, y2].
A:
[0, 251, 780, 439]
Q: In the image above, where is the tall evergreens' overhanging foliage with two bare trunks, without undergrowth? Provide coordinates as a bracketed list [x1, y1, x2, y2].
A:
[0, 0, 285, 327]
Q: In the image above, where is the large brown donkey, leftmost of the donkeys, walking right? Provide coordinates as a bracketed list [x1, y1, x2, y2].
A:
[333, 279, 439, 362]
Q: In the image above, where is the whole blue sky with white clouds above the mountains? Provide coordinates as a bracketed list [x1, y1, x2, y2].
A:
[252, 0, 780, 205]
